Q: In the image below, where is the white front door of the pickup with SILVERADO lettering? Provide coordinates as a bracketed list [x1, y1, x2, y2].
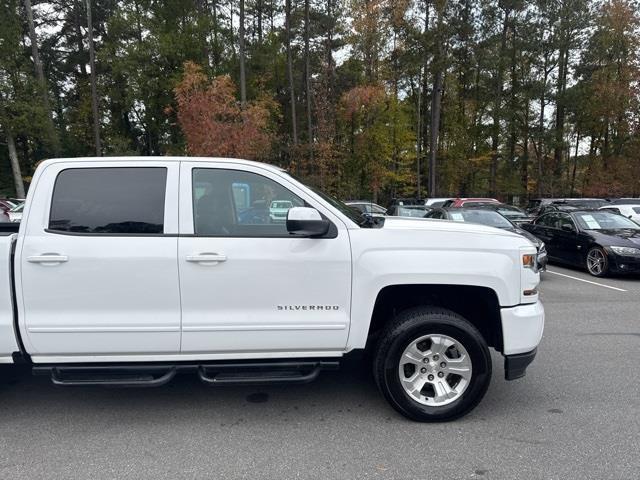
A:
[178, 162, 351, 357]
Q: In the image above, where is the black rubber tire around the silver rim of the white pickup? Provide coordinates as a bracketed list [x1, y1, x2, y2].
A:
[373, 307, 492, 422]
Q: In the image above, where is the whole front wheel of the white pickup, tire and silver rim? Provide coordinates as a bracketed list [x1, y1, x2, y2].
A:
[373, 307, 491, 422]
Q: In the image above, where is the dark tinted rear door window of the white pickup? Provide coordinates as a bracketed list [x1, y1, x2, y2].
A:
[49, 167, 167, 234]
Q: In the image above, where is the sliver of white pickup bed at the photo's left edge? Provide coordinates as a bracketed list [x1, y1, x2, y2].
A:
[0, 233, 19, 363]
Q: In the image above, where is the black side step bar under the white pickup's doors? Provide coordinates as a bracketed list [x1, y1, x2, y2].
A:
[32, 361, 340, 387]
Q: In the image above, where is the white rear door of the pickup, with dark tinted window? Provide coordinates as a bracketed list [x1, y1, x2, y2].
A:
[17, 160, 180, 356]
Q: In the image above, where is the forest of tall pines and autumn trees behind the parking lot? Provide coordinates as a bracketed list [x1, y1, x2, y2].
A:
[0, 0, 640, 202]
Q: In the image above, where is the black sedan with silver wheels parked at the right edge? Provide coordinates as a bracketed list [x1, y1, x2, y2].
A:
[522, 210, 640, 277]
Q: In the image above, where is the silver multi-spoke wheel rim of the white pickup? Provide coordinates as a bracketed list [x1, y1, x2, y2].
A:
[398, 333, 472, 407]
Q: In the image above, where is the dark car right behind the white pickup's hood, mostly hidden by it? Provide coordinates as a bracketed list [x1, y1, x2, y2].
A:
[426, 207, 547, 270]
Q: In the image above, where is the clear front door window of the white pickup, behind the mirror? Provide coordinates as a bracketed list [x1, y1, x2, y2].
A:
[192, 168, 305, 237]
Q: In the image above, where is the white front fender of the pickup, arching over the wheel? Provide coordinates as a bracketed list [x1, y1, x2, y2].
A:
[347, 231, 520, 349]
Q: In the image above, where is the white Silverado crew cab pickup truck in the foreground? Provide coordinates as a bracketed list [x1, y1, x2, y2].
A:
[0, 157, 544, 421]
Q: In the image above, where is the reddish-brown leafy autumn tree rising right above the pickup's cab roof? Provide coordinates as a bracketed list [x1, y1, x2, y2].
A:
[174, 62, 275, 160]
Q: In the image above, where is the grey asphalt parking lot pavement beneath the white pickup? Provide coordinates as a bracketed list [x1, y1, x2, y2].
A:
[0, 266, 640, 480]
